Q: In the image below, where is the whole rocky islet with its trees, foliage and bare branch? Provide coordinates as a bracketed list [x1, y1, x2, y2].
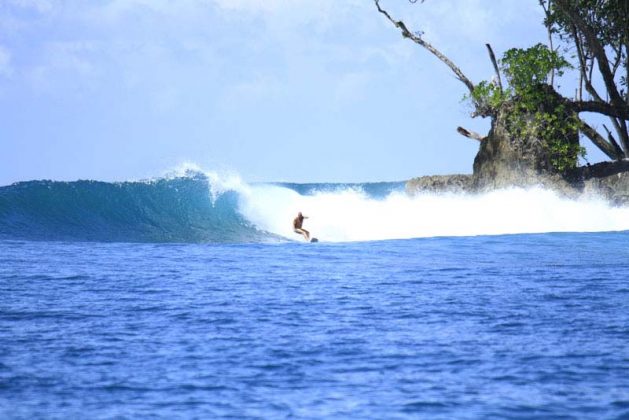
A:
[374, 0, 629, 205]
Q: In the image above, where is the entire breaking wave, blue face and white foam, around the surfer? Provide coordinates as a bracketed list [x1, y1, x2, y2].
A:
[0, 171, 629, 243]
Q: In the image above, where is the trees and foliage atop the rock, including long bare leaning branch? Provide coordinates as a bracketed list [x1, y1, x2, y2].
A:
[374, 0, 629, 174]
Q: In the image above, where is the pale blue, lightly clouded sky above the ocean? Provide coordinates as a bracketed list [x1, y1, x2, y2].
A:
[0, 0, 608, 185]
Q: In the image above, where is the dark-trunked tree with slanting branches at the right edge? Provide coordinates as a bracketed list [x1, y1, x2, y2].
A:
[540, 0, 629, 159]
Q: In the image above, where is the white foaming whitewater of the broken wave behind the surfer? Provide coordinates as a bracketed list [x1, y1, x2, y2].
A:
[239, 186, 629, 242]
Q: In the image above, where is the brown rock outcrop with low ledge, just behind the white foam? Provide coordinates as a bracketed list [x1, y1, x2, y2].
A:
[406, 86, 629, 205]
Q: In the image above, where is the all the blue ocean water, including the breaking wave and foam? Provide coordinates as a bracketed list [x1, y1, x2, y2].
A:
[0, 171, 629, 419]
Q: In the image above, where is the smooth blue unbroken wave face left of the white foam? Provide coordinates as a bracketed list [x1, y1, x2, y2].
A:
[0, 173, 268, 242]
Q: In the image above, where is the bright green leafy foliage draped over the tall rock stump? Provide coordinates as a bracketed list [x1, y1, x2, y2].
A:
[467, 44, 585, 172]
